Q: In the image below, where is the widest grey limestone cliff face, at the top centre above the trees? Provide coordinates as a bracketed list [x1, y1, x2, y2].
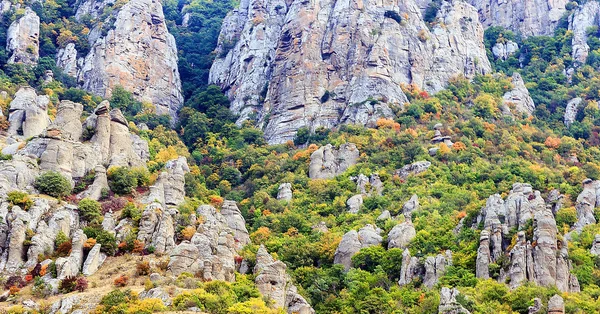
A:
[209, 0, 490, 143]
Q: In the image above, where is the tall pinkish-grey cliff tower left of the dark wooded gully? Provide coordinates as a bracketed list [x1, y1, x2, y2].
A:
[78, 0, 183, 120]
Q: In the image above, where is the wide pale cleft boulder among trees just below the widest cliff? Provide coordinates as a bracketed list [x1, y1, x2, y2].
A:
[308, 143, 360, 179]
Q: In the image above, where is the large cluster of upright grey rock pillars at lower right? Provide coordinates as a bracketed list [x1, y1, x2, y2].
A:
[476, 180, 580, 292]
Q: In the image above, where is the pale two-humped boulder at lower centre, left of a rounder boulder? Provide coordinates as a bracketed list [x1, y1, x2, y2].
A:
[333, 225, 383, 270]
